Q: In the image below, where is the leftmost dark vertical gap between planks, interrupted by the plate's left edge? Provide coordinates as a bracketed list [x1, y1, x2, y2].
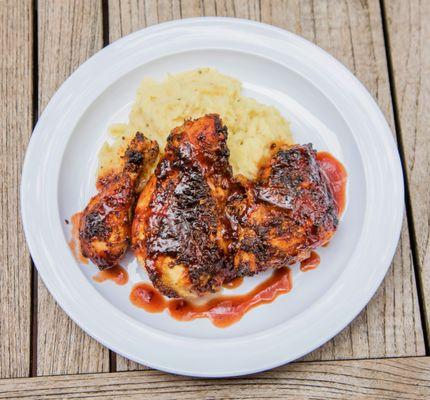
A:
[29, 0, 39, 377]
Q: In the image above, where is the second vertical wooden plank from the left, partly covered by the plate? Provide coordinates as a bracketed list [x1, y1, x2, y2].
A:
[37, 0, 109, 375]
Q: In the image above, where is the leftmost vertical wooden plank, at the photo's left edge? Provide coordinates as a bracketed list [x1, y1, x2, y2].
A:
[0, 0, 33, 378]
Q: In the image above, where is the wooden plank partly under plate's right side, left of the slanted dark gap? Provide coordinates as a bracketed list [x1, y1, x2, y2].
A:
[261, 0, 425, 359]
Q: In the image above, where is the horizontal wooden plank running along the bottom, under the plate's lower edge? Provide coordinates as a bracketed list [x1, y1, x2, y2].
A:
[0, 357, 430, 400]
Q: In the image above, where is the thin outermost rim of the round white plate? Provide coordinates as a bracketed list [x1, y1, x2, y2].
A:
[20, 17, 404, 377]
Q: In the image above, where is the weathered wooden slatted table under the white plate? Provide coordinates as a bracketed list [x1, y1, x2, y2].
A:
[0, 0, 430, 399]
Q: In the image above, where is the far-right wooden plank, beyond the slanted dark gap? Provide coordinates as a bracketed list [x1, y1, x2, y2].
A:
[385, 0, 430, 341]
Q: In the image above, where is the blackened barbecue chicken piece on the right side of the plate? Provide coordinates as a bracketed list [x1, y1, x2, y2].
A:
[226, 144, 338, 276]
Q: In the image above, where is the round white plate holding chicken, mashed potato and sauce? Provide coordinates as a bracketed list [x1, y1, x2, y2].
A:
[21, 18, 403, 377]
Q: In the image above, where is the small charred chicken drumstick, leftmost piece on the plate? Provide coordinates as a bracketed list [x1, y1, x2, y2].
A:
[79, 132, 158, 269]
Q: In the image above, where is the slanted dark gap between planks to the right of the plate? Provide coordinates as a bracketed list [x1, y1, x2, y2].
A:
[379, 0, 430, 355]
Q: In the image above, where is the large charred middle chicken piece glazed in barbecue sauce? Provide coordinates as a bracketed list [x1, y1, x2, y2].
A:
[132, 115, 232, 297]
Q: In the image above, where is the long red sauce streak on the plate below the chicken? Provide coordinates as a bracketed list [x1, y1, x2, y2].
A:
[130, 268, 292, 328]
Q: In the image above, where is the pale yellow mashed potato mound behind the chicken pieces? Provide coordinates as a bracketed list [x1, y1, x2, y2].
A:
[99, 68, 293, 178]
